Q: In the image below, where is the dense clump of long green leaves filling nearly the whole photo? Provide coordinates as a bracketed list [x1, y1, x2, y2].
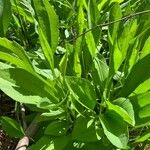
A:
[0, 0, 150, 150]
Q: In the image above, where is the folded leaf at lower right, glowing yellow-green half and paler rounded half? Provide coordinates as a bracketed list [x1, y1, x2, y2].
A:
[106, 98, 135, 126]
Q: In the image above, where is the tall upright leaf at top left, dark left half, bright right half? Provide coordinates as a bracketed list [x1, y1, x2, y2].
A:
[32, 0, 59, 53]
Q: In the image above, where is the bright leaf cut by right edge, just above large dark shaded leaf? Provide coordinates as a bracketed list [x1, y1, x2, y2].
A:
[140, 37, 150, 59]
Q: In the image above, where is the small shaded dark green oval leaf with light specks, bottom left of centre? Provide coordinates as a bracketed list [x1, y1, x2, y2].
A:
[44, 120, 69, 136]
